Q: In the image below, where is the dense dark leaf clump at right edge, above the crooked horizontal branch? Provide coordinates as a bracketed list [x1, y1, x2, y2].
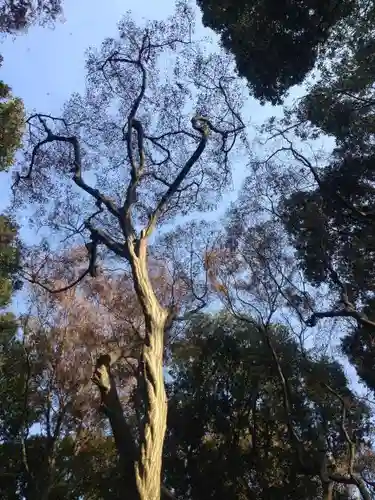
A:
[281, 153, 375, 300]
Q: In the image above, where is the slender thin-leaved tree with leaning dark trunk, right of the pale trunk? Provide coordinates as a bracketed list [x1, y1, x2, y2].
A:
[198, 189, 369, 498]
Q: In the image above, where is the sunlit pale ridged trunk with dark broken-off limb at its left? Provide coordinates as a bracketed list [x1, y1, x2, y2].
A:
[93, 238, 170, 500]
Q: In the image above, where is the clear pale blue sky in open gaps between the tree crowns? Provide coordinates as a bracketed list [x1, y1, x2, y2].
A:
[0, 0, 364, 390]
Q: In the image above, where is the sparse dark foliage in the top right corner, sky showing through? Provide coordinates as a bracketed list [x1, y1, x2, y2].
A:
[297, 2, 375, 148]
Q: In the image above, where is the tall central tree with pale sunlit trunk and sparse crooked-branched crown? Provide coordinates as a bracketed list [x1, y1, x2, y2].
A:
[10, 5, 244, 500]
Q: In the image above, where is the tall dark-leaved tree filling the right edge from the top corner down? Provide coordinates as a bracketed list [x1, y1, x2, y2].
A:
[250, 0, 375, 398]
